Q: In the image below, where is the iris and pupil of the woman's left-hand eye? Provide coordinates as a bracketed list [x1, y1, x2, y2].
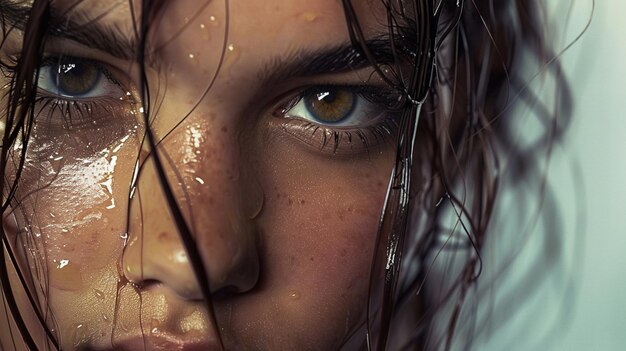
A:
[50, 62, 101, 96]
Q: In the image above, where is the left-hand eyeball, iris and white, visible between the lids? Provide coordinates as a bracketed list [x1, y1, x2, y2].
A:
[38, 57, 108, 98]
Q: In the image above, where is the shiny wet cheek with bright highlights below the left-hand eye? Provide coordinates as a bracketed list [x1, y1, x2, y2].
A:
[9, 129, 137, 291]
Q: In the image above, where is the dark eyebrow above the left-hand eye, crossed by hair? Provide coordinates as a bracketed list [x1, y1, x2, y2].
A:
[0, 0, 137, 60]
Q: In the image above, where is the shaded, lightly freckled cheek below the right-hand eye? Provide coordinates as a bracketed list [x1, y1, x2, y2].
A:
[229, 135, 392, 350]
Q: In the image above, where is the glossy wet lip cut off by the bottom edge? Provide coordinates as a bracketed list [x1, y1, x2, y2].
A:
[91, 333, 222, 351]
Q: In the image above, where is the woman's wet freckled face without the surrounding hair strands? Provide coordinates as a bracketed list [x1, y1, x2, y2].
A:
[0, 0, 396, 350]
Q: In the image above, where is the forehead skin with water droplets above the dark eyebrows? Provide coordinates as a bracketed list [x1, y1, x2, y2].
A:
[40, 0, 387, 64]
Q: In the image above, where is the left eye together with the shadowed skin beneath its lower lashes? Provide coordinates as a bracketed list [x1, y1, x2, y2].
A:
[29, 55, 138, 156]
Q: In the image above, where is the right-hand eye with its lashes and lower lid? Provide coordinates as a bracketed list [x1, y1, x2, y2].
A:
[275, 85, 403, 154]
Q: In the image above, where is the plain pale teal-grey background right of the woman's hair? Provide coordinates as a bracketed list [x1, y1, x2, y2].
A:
[473, 0, 626, 351]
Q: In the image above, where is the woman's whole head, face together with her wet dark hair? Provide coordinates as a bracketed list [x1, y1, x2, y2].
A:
[0, 0, 570, 350]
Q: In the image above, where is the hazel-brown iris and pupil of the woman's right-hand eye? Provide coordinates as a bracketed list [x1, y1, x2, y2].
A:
[302, 88, 357, 124]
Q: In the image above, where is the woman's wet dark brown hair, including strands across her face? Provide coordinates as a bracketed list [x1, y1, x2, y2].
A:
[0, 0, 570, 350]
